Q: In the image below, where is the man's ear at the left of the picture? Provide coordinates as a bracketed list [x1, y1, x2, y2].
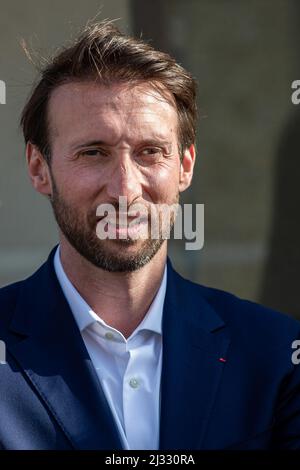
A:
[26, 142, 52, 196]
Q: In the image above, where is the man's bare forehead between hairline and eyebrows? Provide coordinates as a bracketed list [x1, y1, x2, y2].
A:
[48, 82, 177, 142]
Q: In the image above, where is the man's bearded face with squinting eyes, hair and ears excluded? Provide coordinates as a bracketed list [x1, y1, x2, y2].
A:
[41, 82, 195, 272]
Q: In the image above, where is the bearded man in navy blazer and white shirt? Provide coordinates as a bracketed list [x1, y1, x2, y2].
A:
[0, 22, 300, 449]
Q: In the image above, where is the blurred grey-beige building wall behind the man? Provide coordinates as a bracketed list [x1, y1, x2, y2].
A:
[0, 0, 300, 318]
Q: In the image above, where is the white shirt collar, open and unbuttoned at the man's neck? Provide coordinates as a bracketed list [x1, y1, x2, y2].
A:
[54, 246, 167, 336]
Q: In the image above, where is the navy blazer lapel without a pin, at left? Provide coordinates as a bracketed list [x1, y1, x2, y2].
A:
[7, 250, 122, 449]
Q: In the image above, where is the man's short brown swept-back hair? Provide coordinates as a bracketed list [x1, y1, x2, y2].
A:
[20, 20, 197, 163]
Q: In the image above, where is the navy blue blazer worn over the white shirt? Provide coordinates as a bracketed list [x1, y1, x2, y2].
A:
[0, 251, 300, 450]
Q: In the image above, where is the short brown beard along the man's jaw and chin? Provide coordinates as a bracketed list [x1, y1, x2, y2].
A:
[50, 174, 179, 273]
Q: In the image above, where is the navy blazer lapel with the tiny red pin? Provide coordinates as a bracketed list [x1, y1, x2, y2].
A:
[160, 262, 230, 449]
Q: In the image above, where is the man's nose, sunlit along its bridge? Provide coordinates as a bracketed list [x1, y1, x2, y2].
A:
[107, 155, 142, 206]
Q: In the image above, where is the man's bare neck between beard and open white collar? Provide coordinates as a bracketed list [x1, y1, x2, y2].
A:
[60, 238, 167, 338]
